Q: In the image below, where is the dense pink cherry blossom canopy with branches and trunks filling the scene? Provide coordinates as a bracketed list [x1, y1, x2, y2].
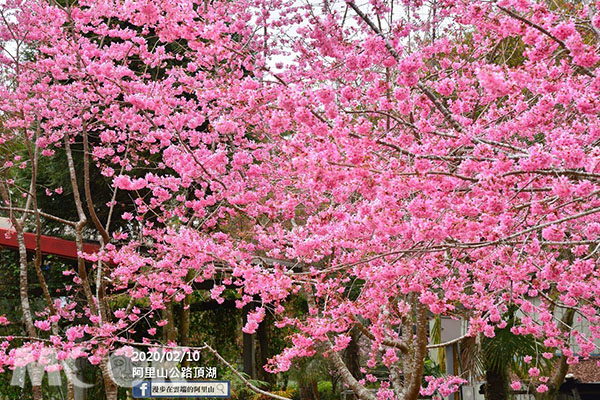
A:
[0, 0, 600, 400]
